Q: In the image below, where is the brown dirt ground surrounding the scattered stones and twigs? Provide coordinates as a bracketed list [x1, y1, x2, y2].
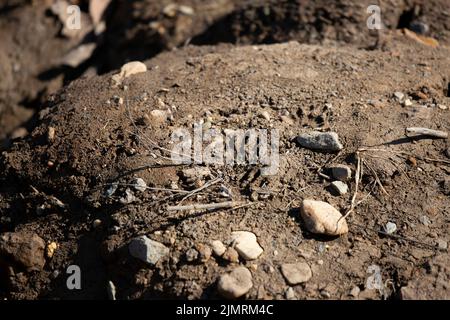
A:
[0, 0, 450, 299]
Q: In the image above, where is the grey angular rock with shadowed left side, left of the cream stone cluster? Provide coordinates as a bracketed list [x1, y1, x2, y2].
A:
[128, 236, 170, 265]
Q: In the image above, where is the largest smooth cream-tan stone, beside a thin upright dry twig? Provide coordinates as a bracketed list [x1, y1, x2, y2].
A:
[300, 199, 348, 235]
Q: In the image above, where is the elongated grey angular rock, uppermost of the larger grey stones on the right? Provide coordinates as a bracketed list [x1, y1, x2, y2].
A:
[297, 131, 344, 152]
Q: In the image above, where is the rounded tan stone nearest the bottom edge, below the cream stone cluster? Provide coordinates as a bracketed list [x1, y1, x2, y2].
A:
[217, 267, 253, 299]
